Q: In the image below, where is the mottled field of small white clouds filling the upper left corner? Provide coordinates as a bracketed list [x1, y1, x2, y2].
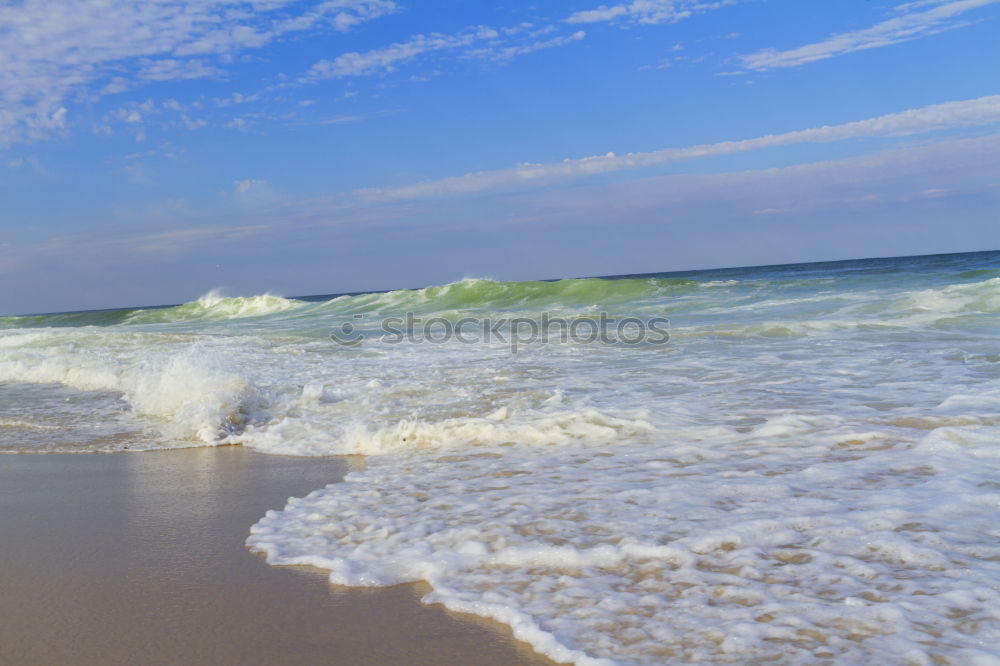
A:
[0, 0, 397, 146]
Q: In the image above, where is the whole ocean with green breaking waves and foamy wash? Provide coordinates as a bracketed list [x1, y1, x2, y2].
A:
[0, 252, 1000, 665]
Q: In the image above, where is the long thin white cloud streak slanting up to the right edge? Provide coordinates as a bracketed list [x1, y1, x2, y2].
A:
[356, 95, 1000, 200]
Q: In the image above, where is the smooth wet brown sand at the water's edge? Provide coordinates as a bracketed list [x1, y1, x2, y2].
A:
[0, 447, 552, 666]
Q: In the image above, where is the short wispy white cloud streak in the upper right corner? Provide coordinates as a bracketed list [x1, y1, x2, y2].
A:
[740, 0, 1000, 70]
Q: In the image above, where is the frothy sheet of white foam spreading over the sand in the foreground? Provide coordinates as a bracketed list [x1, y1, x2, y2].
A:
[248, 416, 1000, 664]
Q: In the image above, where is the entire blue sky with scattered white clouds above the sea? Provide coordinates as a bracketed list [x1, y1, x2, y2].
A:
[0, 0, 1000, 314]
